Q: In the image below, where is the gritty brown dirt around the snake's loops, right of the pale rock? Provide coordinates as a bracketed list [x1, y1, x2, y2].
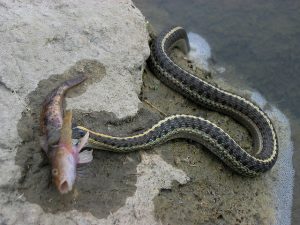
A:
[143, 51, 275, 225]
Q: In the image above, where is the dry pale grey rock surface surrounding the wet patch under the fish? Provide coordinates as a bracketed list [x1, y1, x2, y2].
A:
[0, 0, 188, 224]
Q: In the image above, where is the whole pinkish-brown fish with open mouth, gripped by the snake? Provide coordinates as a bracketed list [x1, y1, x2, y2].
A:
[40, 76, 93, 193]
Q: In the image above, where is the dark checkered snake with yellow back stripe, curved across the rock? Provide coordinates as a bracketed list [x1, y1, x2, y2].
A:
[77, 27, 278, 176]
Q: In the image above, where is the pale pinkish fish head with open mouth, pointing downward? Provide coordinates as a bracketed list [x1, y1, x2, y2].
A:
[52, 146, 78, 194]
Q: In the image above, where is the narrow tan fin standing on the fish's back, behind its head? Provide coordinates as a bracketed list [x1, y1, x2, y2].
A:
[59, 110, 72, 148]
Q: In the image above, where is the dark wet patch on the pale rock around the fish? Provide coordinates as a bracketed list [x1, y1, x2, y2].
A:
[16, 60, 155, 218]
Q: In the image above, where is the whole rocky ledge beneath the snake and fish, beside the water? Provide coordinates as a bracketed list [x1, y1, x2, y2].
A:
[0, 0, 290, 225]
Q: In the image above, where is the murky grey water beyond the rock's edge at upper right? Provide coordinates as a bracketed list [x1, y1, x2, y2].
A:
[134, 0, 300, 225]
